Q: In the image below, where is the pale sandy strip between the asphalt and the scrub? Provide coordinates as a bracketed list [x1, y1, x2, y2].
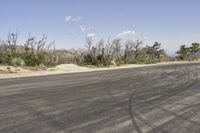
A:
[0, 61, 200, 79]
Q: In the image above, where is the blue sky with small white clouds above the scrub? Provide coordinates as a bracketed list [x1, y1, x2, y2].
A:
[0, 0, 200, 53]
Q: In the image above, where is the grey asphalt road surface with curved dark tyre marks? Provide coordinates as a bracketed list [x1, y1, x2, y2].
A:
[0, 64, 200, 133]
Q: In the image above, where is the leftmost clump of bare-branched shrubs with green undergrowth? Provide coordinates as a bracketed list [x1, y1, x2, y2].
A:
[0, 33, 59, 66]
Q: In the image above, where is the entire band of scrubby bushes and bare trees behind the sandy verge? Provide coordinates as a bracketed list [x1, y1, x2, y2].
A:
[0, 33, 200, 67]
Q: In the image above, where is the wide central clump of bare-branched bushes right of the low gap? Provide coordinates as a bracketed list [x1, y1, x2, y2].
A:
[84, 38, 169, 66]
